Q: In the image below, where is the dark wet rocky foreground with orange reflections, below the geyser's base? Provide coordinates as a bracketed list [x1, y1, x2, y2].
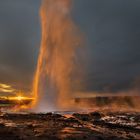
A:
[0, 111, 140, 140]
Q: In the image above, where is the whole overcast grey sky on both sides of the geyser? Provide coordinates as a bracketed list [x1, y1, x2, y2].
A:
[0, 0, 140, 91]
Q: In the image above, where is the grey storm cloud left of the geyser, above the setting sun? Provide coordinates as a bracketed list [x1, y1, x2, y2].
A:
[0, 0, 40, 91]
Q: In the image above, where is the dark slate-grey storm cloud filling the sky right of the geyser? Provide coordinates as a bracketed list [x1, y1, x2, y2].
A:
[74, 0, 140, 91]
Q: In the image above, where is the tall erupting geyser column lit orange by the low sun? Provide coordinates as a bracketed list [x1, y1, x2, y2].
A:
[33, 0, 80, 111]
